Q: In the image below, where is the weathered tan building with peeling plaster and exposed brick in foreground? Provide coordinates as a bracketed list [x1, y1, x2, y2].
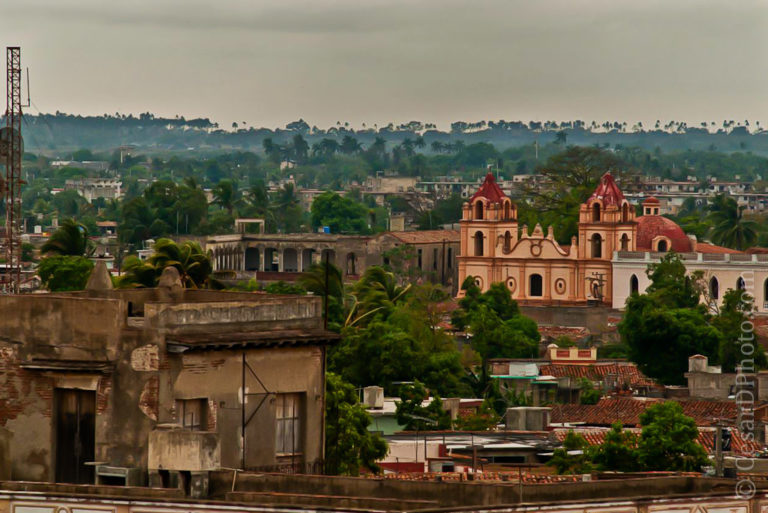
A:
[0, 266, 336, 483]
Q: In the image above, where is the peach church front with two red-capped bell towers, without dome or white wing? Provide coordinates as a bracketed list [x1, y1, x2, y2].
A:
[458, 173, 637, 306]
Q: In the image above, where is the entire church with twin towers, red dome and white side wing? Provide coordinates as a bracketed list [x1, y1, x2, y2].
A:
[458, 173, 768, 313]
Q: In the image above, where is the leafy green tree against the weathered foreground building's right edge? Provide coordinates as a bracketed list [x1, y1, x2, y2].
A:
[325, 372, 388, 476]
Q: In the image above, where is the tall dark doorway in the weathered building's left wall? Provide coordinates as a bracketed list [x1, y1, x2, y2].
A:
[54, 388, 96, 484]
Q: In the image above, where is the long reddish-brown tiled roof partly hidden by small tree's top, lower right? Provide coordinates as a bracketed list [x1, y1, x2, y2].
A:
[551, 397, 738, 427]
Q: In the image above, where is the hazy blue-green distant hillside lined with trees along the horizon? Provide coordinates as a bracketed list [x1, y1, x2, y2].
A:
[6, 113, 768, 156]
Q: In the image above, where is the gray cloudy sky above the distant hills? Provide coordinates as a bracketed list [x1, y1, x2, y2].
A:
[0, 0, 768, 127]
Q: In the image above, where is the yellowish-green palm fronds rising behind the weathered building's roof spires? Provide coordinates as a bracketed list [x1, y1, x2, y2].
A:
[119, 239, 213, 289]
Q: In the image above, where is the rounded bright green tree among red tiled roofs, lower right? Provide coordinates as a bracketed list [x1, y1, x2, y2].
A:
[638, 401, 708, 472]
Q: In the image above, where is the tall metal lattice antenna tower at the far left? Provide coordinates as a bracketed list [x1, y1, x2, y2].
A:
[5, 46, 24, 294]
